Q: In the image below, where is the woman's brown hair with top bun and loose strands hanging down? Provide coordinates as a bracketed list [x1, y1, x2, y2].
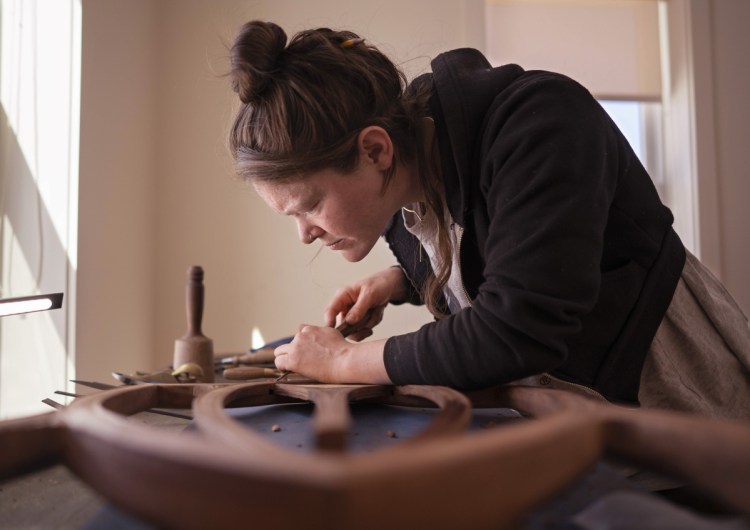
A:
[229, 21, 451, 316]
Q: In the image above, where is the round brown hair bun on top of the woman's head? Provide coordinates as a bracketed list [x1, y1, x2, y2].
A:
[231, 20, 287, 103]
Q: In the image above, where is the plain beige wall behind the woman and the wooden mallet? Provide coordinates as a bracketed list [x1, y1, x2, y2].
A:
[76, 0, 750, 380]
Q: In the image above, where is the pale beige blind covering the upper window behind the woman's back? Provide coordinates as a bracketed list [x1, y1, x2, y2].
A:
[486, 0, 661, 101]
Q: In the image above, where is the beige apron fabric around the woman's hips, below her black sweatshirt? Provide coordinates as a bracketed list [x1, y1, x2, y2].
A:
[638, 253, 750, 420]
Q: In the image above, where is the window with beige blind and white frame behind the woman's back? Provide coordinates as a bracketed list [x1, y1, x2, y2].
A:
[485, 0, 721, 256]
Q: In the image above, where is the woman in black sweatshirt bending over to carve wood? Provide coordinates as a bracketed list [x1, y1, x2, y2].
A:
[230, 21, 750, 418]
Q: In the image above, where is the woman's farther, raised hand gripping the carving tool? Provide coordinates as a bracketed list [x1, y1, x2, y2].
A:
[325, 267, 406, 341]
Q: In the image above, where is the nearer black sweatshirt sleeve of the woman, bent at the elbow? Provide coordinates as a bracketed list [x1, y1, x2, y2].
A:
[384, 72, 634, 388]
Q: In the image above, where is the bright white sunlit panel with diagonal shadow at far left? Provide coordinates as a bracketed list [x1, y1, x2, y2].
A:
[0, 0, 81, 418]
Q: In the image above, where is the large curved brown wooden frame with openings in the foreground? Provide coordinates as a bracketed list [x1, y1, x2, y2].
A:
[0, 382, 750, 529]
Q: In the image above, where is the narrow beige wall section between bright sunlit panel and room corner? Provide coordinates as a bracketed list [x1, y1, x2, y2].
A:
[76, 0, 161, 383]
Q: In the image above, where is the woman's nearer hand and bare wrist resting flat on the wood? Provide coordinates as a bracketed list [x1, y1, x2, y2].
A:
[274, 325, 390, 384]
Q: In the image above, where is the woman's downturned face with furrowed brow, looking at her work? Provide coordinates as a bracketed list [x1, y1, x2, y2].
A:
[254, 159, 402, 262]
